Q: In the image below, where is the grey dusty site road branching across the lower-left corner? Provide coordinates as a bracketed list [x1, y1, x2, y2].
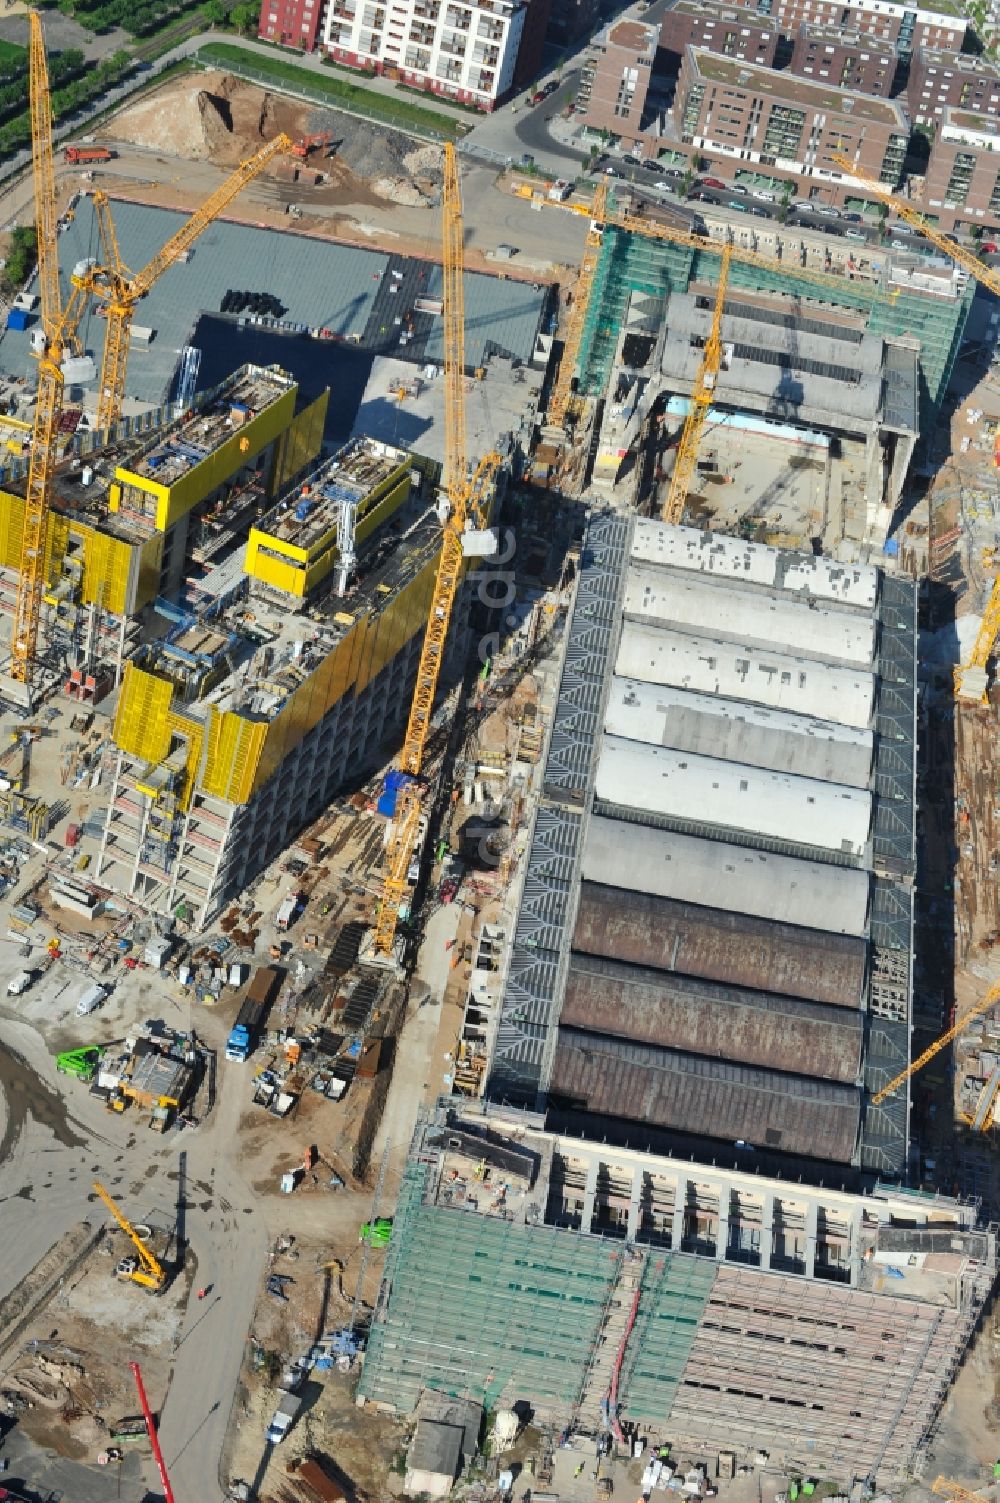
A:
[0, 997, 266, 1503]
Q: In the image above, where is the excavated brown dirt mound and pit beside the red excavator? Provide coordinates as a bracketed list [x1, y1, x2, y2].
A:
[105, 74, 442, 207]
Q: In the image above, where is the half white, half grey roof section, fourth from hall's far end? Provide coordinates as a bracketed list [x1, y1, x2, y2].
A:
[605, 678, 874, 788]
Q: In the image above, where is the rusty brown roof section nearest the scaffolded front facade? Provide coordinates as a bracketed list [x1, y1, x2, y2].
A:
[549, 1028, 860, 1163]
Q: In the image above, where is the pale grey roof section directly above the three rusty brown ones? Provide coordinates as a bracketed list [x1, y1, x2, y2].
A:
[582, 815, 869, 936]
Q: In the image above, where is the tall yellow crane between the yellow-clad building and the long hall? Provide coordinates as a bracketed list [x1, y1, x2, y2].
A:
[374, 143, 501, 956]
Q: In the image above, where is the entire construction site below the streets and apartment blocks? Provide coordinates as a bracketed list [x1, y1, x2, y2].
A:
[0, 2, 1000, 1503]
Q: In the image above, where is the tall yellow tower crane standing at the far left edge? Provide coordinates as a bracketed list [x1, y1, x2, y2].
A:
[11, 11, 87, 694]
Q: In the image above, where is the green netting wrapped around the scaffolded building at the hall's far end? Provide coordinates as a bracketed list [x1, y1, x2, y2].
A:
[579, 228, 976, 436]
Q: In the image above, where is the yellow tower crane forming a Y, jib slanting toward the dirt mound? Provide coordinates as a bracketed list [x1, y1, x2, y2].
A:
[90, 135, 292, 431]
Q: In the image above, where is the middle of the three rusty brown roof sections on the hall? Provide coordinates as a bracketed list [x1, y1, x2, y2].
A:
[559, 954, 863, 1085]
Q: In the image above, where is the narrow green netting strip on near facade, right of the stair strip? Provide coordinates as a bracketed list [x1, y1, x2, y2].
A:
[618, 1250, 716, 1425]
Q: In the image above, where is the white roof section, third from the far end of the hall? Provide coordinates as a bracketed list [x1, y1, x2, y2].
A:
[615, 621, 875, 729]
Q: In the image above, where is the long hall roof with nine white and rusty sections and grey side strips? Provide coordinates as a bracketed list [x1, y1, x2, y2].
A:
[487, 514, 916, 1183]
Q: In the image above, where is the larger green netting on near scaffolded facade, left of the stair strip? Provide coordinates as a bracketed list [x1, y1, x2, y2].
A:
[359, 1163, 623, 1411]
